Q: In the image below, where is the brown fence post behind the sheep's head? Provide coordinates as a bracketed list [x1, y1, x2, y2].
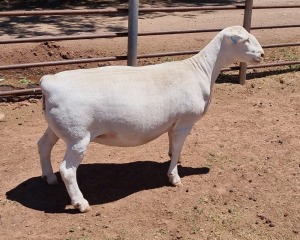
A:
[239, 0, 253, 85]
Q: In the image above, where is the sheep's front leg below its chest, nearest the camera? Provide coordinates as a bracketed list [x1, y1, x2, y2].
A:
[168, 127, 191, 186]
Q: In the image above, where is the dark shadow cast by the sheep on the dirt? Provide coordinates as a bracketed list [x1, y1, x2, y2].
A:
[6, 161, 209, 213]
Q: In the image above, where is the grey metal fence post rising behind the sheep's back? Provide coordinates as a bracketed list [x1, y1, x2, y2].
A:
[127, 0, 139, 66]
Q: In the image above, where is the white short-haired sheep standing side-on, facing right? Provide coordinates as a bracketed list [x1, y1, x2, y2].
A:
[38, 26, 264, 212]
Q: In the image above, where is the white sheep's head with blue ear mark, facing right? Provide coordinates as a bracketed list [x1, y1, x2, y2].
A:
[222, 26, 264, 63]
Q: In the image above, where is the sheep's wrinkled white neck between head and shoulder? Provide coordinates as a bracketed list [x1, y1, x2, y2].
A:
[189, 35, 229, 87]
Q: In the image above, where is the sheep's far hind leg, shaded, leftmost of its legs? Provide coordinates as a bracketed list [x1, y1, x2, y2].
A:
[38, 127, 59, 185]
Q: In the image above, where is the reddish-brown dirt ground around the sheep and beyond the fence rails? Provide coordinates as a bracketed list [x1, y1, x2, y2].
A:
[0, 0, 300, 240]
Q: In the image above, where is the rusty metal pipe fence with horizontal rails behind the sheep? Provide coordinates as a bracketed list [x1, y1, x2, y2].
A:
[0, 0, 300, 96]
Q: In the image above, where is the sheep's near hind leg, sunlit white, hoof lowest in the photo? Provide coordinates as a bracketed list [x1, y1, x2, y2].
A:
[60, 140, 91, 212]
